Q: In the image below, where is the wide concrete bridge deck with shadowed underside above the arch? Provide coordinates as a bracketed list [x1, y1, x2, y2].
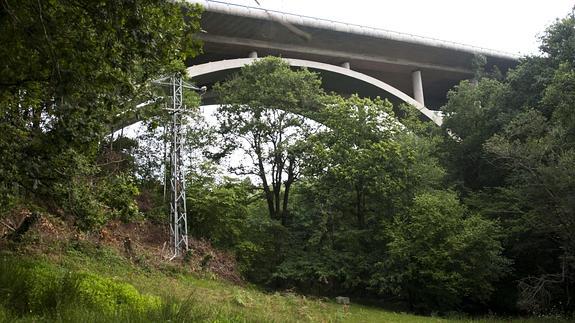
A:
[190, 1, 517, 108]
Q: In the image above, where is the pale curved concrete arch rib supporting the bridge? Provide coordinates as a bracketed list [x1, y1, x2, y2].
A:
[187, 58, 443, 126]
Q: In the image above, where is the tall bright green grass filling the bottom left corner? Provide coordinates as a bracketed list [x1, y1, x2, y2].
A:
[0, 256, 241, 322]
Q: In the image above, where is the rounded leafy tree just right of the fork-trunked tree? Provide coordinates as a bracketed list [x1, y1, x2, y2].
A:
[306, 95, 409, 229]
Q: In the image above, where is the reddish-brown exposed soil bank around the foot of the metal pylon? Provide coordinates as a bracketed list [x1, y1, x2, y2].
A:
[0, 209, 244, 284]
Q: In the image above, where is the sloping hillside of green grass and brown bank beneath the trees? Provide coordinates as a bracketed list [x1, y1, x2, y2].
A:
[0, 210, 559, 322]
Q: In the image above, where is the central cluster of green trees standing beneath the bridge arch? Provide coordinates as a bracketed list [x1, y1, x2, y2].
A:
[189, 58, 508, 311]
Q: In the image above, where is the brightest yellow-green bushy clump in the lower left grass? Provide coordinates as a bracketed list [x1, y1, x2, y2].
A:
[0, 259, 162, 315]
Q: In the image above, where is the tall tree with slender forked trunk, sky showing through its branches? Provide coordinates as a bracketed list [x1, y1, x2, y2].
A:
[215, 57, 323, 224]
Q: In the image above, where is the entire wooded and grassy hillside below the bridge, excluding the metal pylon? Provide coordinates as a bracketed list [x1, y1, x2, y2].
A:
[0, 0, 575, 322]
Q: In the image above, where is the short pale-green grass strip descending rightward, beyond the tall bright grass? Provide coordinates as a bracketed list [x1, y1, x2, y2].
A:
[0, 246, 568, 322]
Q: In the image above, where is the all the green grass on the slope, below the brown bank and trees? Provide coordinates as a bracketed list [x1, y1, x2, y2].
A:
[0, 244, 561, 322]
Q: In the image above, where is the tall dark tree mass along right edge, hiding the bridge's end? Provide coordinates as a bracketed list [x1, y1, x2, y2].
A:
[438, 9, 575, 313]
